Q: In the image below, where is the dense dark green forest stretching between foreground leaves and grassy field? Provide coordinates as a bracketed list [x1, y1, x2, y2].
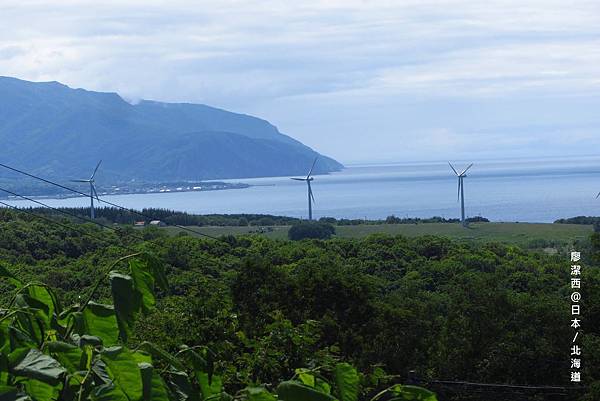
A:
[0, 210, 600, 400]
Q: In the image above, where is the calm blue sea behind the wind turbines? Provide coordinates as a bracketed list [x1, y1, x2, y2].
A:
[5, 156, 600, 222]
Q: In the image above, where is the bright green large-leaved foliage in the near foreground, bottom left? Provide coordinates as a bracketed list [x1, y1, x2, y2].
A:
[0, 255, 436, 401]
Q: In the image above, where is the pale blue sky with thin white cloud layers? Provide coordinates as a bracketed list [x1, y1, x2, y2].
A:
[0, 0, 600, 163]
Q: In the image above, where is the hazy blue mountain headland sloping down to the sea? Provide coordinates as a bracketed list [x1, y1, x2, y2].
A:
[0, 77, 343, 182]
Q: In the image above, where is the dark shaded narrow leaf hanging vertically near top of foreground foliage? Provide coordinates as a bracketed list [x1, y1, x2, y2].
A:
[109, 272, 141, 342]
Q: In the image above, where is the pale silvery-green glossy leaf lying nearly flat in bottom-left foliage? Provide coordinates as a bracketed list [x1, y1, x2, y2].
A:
[8, 348, 67, 384]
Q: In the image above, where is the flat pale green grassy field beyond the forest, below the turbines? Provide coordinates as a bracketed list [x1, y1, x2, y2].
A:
[165, 223, 592, 247]
